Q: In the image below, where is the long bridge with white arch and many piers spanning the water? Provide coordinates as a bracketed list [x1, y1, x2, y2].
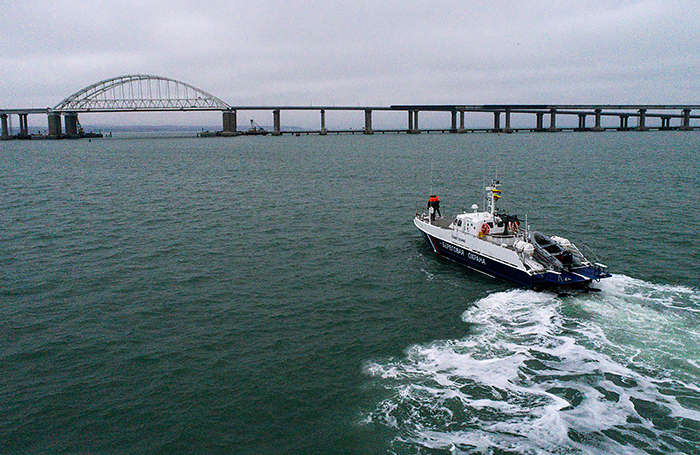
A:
[0, 74, 700, 139]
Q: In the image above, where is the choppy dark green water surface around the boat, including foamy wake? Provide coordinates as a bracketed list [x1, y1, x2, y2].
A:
[0, 132, 700, 454]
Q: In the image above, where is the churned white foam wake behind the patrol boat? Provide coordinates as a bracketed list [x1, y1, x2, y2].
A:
[365, 276, 700, 453]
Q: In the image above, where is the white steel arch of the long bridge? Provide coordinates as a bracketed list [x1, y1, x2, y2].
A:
[53, 74, 230, 112]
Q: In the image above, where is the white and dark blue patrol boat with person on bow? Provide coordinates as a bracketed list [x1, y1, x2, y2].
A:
[413, 180, 612, 291]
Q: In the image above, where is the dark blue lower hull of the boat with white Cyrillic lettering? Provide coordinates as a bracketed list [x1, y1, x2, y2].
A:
[421, 231, 591, 289]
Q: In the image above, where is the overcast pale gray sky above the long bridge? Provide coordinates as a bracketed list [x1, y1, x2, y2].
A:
[0, 0, 700, 124]
